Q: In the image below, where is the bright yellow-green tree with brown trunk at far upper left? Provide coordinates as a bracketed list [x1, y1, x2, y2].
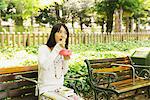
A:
[6, 0, 39, 32]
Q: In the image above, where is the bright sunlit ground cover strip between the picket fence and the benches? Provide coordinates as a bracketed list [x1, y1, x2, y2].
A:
[0, 40, 150, 67]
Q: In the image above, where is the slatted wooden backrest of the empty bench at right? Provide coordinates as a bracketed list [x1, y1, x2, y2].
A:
[85, 57, 132, 84]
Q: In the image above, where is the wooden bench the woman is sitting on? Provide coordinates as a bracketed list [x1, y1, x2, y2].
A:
[0, 65, 84, 100]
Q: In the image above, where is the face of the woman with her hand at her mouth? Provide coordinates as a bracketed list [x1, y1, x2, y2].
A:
[55, 26, 67, 43]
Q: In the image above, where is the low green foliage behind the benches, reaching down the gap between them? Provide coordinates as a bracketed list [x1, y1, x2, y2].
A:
[0, 40, 150, 96]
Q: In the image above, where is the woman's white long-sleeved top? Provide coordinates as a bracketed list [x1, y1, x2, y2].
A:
[38, 44, 68, 94]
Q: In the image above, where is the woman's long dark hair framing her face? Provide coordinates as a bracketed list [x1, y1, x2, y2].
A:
[46, 23, 69, 49]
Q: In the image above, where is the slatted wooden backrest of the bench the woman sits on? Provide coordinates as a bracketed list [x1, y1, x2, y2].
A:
[0, 65, 38, 100]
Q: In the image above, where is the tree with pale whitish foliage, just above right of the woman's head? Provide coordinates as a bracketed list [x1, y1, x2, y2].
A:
[63, 0, 94, 30]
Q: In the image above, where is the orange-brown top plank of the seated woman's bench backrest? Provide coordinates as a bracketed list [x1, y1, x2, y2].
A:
[0, 65, 38, 74]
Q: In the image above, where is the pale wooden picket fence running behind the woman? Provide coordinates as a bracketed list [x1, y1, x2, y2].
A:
[0, 32, 150, 47]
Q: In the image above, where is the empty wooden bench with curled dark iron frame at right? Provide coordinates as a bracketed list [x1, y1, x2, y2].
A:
[85, 57, 150, 100]
